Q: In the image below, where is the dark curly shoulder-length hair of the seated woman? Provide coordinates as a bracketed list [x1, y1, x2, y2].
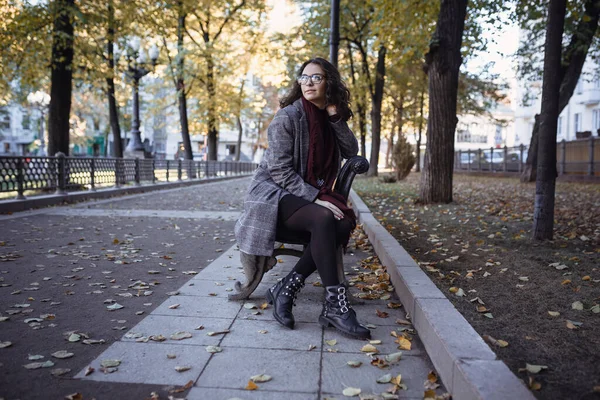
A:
[279, 57, 354, 121]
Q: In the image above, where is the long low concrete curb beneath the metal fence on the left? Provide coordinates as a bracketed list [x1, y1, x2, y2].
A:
[0, 174, 251, 214]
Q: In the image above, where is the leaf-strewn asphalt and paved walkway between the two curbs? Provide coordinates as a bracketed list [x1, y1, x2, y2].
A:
[0, 178, 445, 400]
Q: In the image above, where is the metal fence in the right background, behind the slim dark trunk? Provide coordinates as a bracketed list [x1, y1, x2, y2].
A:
[454, 137, 600, 176]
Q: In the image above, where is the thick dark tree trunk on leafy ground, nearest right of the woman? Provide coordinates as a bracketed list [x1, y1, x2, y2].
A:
[419, 0, 468, 204]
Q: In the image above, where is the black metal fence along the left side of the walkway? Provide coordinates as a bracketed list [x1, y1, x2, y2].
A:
[0, 154, 258, 199]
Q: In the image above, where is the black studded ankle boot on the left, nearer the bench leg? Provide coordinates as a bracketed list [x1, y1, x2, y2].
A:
[267, 271, 304, 329]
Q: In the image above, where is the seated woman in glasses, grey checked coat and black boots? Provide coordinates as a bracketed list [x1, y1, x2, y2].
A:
[235, 58, 371, 339]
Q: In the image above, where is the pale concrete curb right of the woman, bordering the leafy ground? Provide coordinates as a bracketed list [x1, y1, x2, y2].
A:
[350, 190, 535, 400]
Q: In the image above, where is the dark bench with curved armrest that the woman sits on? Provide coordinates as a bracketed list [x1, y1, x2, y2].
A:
[229, 156, 369, 300]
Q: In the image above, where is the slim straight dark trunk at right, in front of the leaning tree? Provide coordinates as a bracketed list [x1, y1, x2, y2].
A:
[533, 0, 567, 240]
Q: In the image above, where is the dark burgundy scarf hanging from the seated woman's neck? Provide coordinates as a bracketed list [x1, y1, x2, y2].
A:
[302, 97, 356, 231]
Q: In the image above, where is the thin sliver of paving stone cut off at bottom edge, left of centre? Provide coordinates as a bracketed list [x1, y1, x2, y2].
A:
[186, 383, 319, 400]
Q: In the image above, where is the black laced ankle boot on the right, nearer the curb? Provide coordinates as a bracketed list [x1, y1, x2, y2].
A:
[319, 285, 371, 339]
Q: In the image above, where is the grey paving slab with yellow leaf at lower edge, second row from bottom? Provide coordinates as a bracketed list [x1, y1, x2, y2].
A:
[196, 347, 321, 393]
